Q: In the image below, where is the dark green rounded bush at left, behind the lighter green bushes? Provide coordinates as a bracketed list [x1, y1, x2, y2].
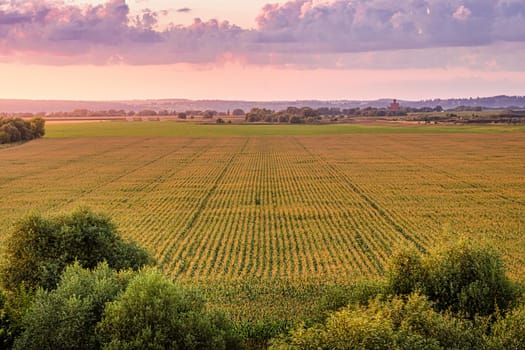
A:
[0, 208, 152, 290]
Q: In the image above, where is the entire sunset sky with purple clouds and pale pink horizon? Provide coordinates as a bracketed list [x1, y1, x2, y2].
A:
[0, 0, 525, 101]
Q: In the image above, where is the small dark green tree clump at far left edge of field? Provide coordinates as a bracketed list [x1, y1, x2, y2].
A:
[0, 117, 46, 144]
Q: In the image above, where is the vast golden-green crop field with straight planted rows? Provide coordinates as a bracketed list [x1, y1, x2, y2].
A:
[0, 123, 525, 318]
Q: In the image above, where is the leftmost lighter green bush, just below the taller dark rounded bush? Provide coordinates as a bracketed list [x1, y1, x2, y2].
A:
[14, 262, 132, 350]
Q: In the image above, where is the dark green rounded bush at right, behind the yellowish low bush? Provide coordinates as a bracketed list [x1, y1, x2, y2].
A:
[387, 241, 519, 318]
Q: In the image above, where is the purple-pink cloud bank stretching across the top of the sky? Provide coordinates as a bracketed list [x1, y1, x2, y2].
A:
[0, 0, 525, 67]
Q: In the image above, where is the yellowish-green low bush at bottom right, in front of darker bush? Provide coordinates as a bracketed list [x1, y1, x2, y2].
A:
[271, 294, 485, 350]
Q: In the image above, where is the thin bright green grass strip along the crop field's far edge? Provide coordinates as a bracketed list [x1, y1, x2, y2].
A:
[46, 121, 525, 138]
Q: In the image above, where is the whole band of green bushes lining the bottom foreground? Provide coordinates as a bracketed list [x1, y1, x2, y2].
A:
[0, 208, 525, 350]
